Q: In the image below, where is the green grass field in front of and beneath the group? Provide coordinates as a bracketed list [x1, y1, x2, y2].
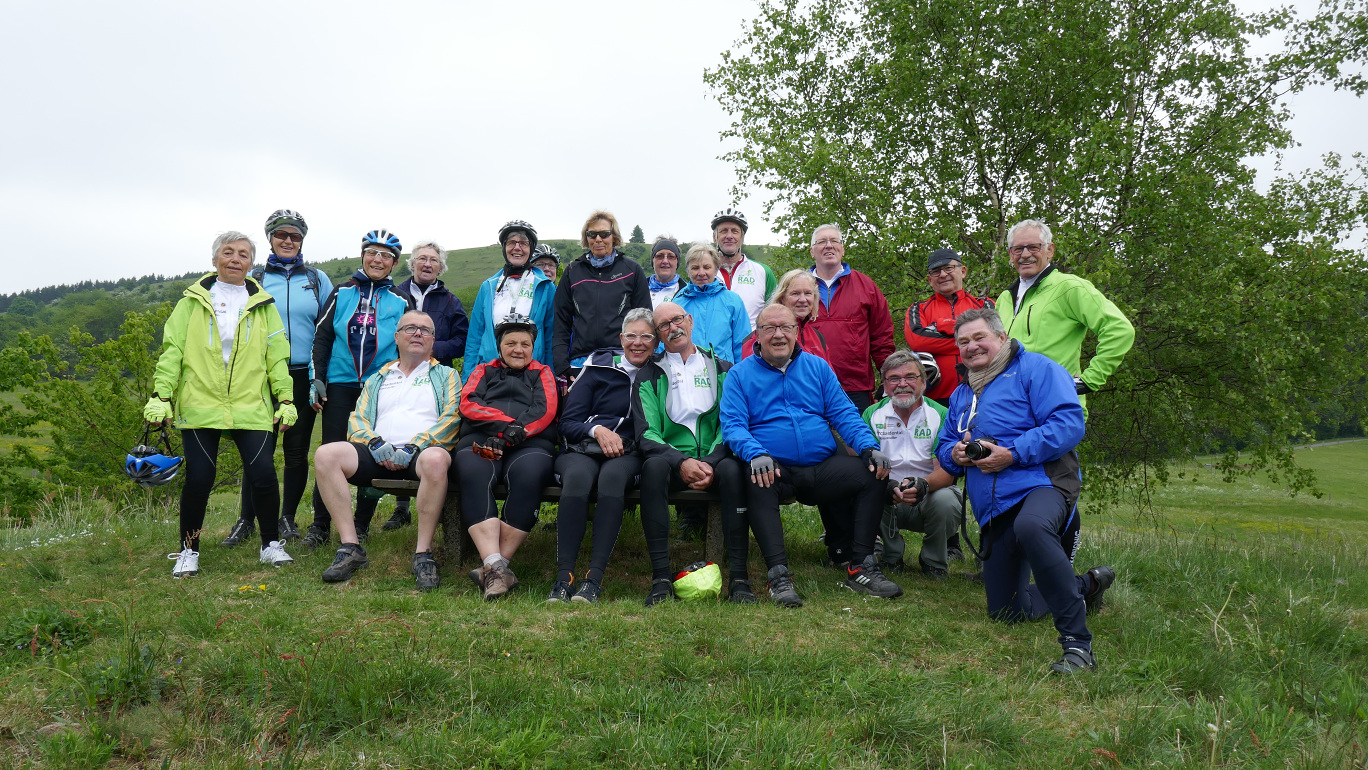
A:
[0, 442, 1368, 769]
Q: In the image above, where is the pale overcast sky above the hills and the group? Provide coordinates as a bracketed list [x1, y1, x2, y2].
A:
[0, 0, 1368, 293]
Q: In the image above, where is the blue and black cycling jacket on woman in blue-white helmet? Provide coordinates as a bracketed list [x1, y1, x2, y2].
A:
[313, 271, 409, 387]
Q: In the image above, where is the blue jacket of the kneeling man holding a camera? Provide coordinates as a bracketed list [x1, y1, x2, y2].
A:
[936, 346, 1083, 527]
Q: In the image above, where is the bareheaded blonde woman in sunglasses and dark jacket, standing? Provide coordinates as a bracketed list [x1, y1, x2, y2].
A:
[551, 211, 651, 379]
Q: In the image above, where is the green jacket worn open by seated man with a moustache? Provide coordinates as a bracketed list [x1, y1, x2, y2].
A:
[632, 347, 732, 469]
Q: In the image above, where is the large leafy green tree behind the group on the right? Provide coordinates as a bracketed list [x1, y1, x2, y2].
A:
[705, 0, 1368, 503]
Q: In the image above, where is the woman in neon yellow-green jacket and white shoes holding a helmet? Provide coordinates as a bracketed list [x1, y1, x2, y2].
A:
[142, 231, 297, 577]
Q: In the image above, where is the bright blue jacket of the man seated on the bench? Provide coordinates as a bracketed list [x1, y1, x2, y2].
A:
[722, 350, 878, 465]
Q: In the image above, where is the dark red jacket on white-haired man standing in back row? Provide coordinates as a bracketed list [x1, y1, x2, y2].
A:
[811, 269, 895, 391]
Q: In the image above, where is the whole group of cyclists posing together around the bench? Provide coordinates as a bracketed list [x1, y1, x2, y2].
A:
[145, 208, 1134, 673]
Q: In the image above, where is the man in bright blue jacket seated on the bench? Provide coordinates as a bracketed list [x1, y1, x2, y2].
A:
[722, 305, 903, 607]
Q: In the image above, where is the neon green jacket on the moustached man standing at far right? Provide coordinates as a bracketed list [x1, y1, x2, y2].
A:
[997, 265, 1135, 401]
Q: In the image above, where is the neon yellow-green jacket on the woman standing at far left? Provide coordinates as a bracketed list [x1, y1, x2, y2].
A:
[153, 274, 292, 431]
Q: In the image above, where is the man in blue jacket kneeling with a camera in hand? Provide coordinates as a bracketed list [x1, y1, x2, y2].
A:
[936, 308, 1116, 674]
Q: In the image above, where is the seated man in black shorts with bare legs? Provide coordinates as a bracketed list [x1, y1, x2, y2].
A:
[313, 310, 461, 591]
